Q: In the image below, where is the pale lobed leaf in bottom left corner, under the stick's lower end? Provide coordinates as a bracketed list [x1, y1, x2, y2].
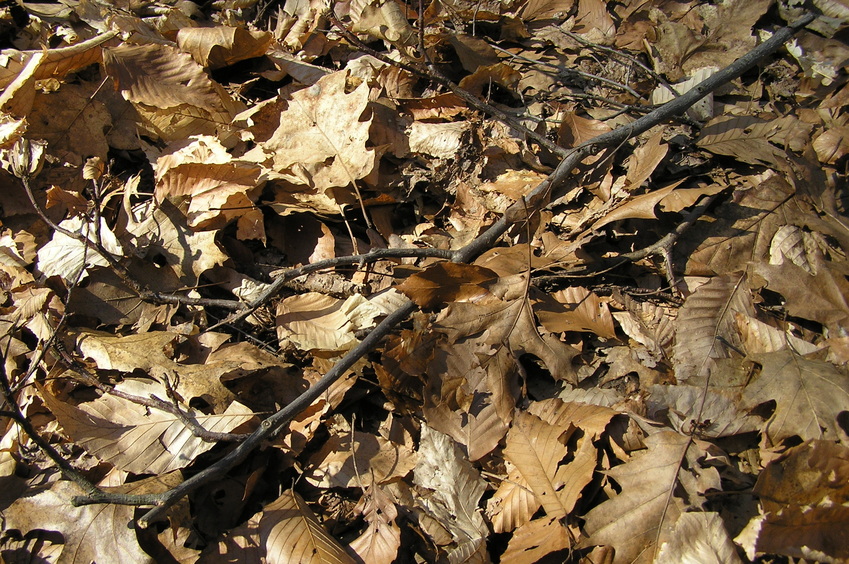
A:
[3, 480, 155, 564]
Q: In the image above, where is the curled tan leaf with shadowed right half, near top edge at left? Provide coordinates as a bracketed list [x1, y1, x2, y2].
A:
[177, 25, 272, 69]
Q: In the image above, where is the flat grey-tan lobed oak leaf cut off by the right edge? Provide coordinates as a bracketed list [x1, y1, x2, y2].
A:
[743, 350, 849, 444]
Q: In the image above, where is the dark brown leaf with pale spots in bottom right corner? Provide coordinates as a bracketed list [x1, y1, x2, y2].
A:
[735, 440, 849, 562]
